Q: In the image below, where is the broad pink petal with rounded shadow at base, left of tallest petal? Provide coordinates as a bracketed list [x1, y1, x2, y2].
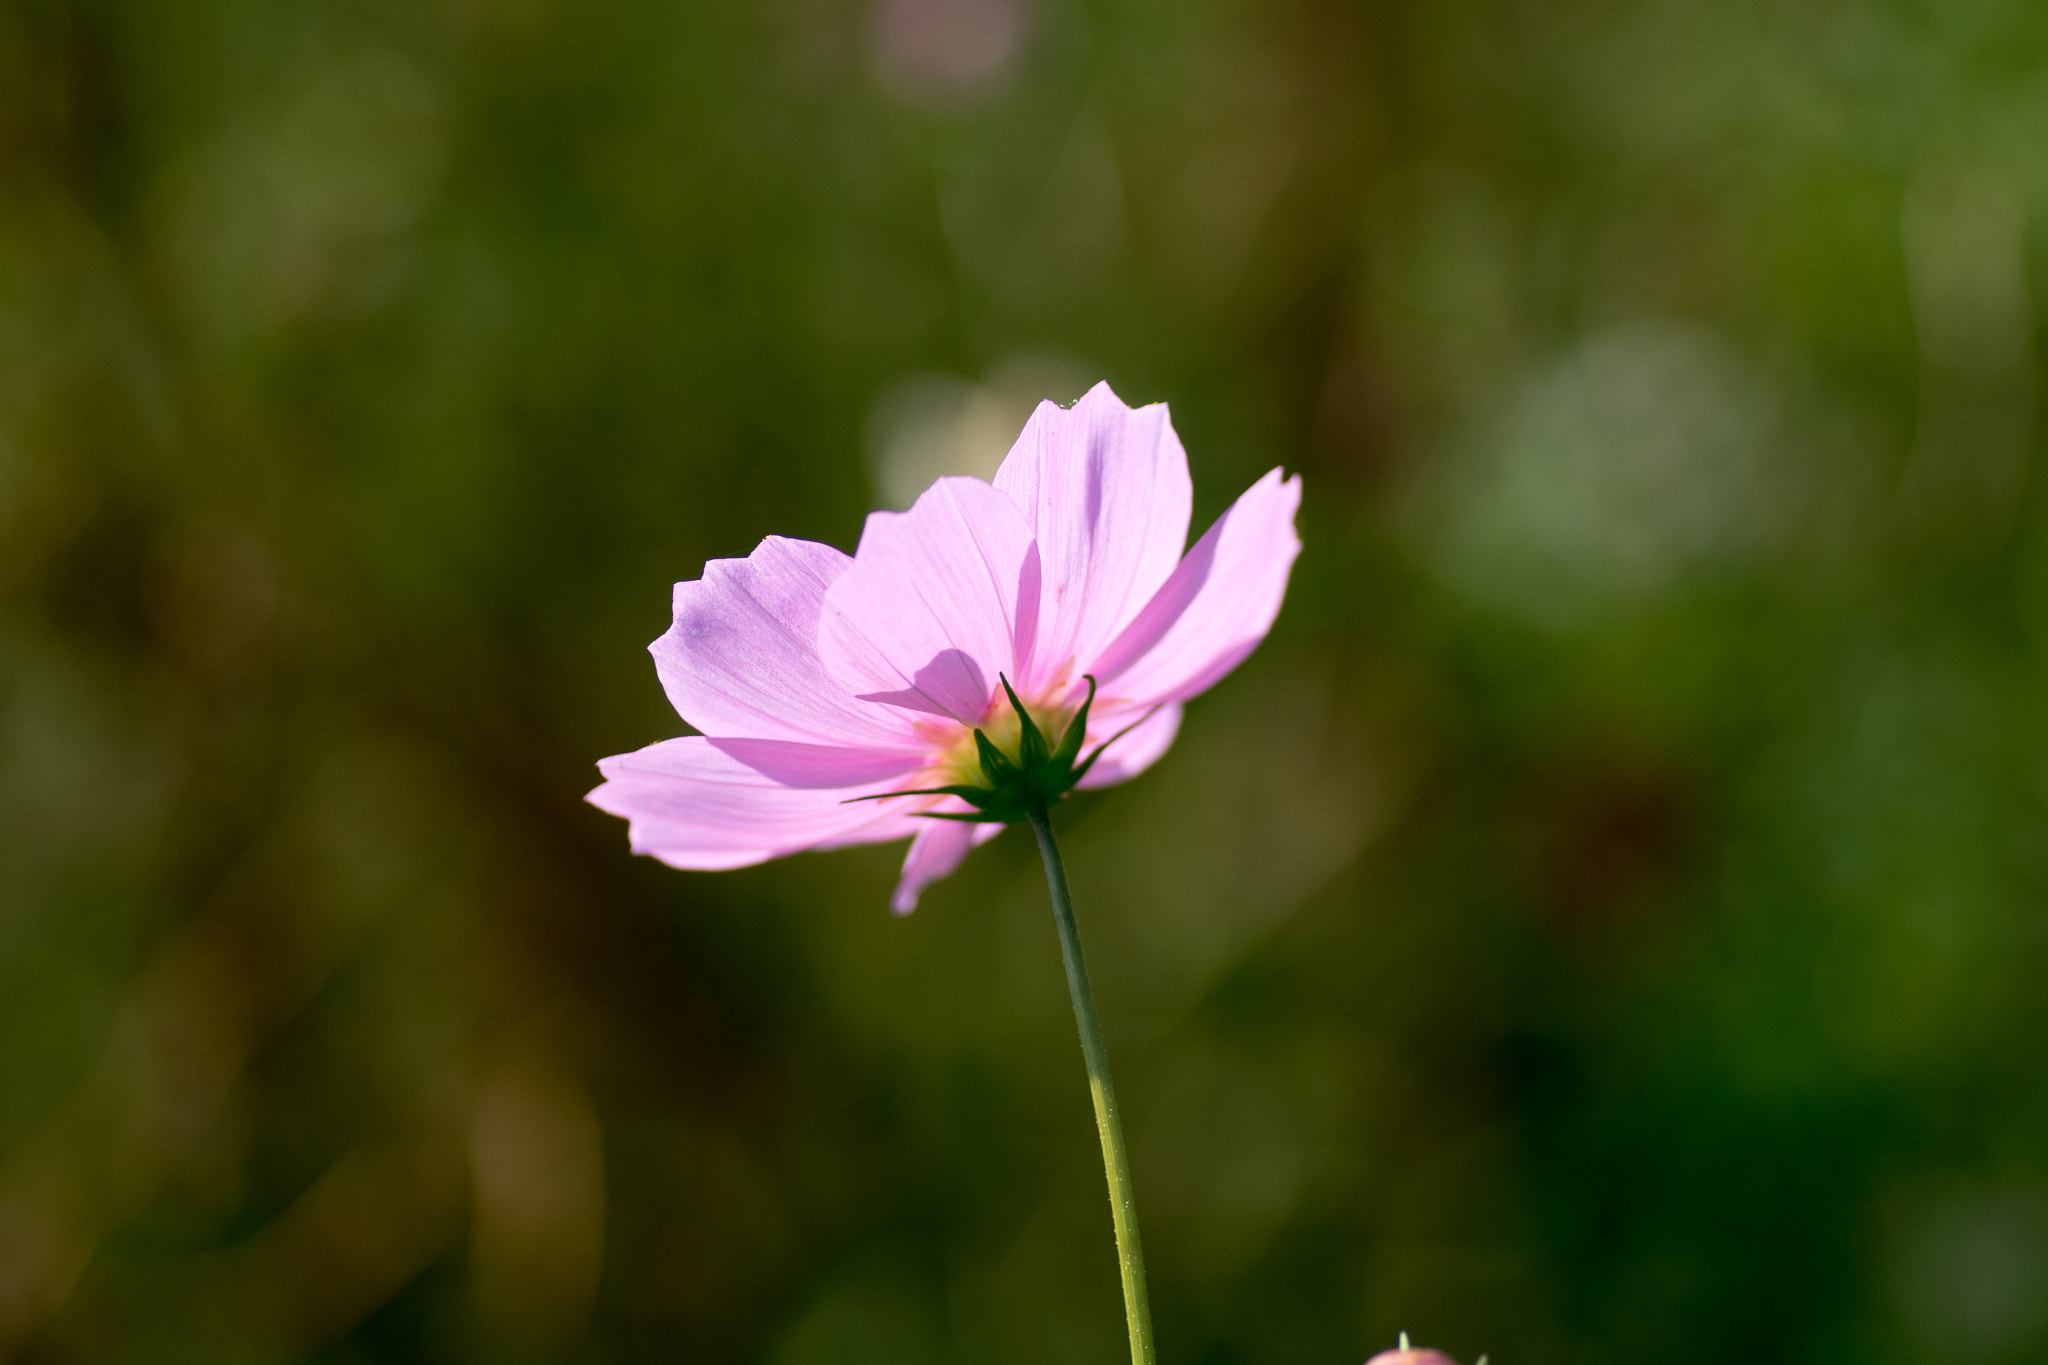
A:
[817, 477, 1040, 724]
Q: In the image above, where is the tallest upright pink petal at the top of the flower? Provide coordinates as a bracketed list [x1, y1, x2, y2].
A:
[995, 383, 1192, 686]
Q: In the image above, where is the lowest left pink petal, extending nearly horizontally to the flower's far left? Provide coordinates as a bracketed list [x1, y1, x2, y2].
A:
[586, 735, 926, 870]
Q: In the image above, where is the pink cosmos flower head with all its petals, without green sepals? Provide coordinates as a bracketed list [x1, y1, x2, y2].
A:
[590, 385, 1300, 913]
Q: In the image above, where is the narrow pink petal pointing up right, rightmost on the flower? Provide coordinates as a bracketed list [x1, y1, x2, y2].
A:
[1092, 469, 1300, 704]
